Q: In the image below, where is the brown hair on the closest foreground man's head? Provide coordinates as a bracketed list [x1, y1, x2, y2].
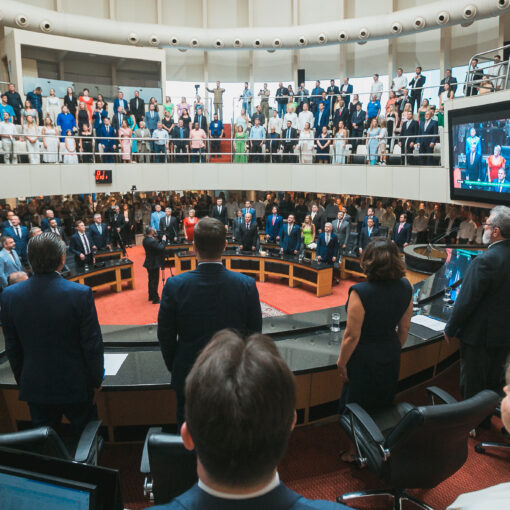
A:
[186, 328, 296, 486]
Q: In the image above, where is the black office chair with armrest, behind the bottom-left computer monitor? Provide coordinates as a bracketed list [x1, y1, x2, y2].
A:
[0, 420, 103, 466]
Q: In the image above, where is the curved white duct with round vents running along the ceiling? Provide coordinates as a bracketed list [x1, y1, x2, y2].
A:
[0, 0, 510, 50]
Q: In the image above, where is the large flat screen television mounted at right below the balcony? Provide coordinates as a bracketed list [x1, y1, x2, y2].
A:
[448, 101, 510, 204]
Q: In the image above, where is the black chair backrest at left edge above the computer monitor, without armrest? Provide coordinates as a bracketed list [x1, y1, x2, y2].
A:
[0, 427, 73, 460]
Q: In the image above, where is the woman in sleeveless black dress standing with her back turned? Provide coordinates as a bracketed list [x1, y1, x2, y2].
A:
[337, 237, 413, 462]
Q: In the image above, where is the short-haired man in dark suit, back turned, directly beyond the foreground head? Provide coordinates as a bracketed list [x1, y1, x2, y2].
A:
[158, 218, 262, 425]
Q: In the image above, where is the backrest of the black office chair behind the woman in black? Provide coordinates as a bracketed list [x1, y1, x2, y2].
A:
[381, 390, 499, 489]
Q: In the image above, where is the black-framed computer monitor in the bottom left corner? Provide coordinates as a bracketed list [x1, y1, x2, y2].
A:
[0, 448, 124, 510]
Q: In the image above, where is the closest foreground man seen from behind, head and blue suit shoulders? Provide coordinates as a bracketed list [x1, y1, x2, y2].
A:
[147, 330, 347, 510]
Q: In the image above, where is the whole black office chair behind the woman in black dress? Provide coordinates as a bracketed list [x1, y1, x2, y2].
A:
[337, 386, 499, 510]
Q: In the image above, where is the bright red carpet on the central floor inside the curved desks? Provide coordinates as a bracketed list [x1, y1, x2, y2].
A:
[95, 246, 352, 324]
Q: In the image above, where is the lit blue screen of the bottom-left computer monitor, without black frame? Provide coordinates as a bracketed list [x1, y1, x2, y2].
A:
[0, 466, 96, 510]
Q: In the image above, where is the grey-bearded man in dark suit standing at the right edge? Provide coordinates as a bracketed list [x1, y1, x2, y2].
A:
[444, 206, 510, 408]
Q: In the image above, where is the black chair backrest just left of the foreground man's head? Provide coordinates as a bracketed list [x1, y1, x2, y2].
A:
[148, 433, 198, 505]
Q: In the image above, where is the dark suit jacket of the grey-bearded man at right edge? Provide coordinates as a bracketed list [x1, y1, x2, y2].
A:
[445, 239, 510, 346]
